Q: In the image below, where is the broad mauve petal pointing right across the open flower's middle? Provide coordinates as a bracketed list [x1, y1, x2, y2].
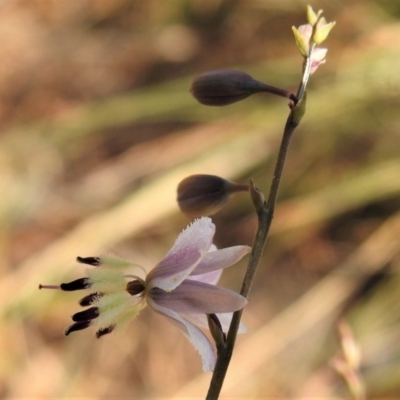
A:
[148, 279, 247, 314]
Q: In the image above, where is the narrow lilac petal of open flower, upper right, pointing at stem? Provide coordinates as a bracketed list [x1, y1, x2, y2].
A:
[191, 246, 251, 276]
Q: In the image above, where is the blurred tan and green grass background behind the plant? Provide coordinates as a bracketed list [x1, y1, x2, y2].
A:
[0, 0, 400, 399]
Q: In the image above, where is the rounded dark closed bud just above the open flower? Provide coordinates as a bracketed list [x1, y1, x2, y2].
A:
[177, 175, 249, 217]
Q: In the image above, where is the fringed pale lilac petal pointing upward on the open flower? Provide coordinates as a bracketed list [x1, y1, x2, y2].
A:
[146, 217, 215, 291]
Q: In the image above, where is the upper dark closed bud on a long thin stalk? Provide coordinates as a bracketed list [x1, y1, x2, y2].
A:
[190, 70, 296, 106]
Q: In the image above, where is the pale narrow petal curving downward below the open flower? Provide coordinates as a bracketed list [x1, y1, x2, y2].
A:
[148, 299, 216, 371]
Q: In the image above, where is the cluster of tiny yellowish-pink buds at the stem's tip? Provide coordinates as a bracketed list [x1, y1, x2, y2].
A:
[292, 6, 336, 74]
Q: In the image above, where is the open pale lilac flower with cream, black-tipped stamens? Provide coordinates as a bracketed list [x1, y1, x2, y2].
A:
[39, 217, 251, 371]
